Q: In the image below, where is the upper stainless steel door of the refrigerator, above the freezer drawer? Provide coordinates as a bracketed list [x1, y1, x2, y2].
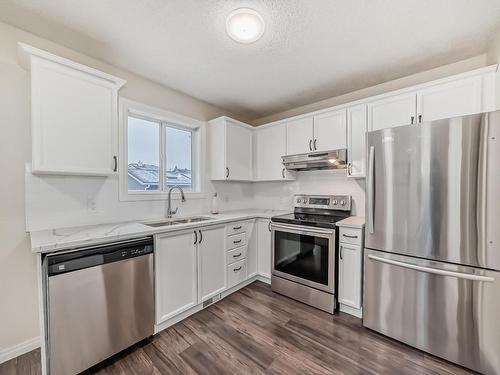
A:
[365, 112, 500, 270]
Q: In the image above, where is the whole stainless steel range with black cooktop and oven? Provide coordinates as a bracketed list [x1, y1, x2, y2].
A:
[271, 195, 351, 314]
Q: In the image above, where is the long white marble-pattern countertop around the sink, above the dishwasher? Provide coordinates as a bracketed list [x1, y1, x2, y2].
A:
[30, 209, 288, 253]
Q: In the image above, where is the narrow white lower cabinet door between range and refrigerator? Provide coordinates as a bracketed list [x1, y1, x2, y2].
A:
[339, 243, 362, 309]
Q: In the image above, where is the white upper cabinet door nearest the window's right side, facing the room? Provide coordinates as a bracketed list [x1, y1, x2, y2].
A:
[226, 119, 253, 181]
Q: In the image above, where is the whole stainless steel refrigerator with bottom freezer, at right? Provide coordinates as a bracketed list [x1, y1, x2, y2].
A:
[363, 111, 500, 374]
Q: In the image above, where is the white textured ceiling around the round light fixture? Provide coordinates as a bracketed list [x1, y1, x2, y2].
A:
[0, 0, 500, 120]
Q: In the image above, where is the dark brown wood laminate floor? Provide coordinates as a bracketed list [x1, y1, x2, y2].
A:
[0, 282, 469, 375]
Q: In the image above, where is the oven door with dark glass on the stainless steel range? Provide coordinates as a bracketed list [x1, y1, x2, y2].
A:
[271, 223, 335, 294]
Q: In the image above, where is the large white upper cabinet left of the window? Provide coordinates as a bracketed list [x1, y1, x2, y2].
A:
[19, 43, 125, 175]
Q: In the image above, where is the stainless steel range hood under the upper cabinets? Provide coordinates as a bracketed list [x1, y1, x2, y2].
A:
[281, 149, 347, 171]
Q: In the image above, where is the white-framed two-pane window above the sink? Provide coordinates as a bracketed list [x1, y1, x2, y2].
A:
[120, 99, 199, 200]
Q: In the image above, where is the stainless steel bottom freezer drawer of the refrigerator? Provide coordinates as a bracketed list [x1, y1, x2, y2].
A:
[363, 249, 500, 374]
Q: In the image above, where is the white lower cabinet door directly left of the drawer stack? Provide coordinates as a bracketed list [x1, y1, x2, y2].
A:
[198, 227, 227, 303]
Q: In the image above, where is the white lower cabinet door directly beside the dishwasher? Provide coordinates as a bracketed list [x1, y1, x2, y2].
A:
[155, 230, 198, 324]
